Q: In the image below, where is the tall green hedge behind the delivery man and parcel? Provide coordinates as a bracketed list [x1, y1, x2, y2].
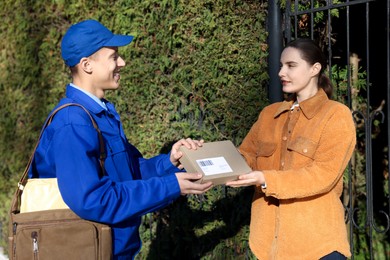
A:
[0, 0, 268, 259]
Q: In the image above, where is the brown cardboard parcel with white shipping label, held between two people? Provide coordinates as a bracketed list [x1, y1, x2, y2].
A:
[180, 140, 252, 185]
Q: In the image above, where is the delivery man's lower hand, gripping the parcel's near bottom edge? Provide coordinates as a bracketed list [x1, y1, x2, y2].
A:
[176, 172, 213, 195]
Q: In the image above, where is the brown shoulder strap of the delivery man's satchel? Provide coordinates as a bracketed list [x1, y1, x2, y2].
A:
[11, 103, 106, 212]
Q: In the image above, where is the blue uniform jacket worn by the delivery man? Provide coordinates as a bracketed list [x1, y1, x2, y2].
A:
[29, 85, 180, 259]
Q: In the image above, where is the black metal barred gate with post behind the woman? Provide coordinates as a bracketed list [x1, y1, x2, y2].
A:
[268, 0, 390, 259]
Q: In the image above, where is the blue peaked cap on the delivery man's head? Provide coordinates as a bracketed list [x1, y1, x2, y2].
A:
[61, 20, 133, 67]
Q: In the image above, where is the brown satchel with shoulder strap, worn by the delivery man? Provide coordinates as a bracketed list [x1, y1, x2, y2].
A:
[8, 103, 112, 260]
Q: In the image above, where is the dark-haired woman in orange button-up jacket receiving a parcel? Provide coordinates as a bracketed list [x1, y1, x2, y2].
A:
[227, 39, 356, 260]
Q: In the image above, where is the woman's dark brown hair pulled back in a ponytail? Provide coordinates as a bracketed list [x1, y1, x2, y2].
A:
[285, 38, 333, 99]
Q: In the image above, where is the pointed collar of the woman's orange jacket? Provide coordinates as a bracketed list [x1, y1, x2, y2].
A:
[274, 88, 329, 119]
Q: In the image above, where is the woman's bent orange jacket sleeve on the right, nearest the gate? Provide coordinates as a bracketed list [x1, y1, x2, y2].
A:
[263, 106, 356, 199]
